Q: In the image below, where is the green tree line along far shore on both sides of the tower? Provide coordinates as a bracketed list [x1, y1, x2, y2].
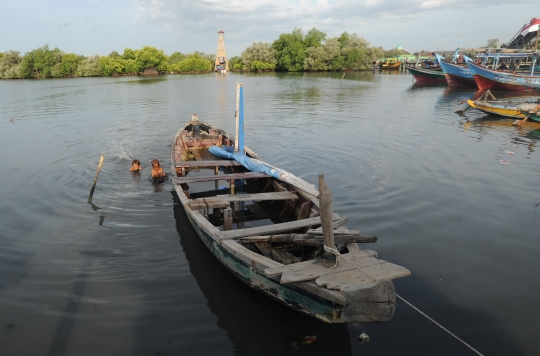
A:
[0, 27, 398, 79]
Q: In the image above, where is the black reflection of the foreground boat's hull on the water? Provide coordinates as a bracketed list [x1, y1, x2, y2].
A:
[173, 193, 351, 355]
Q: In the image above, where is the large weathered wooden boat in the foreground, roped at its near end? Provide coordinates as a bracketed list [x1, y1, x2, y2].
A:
[171, 108, 410, 323]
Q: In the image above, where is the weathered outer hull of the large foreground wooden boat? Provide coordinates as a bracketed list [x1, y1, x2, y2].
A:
[171, 123, 396, 323]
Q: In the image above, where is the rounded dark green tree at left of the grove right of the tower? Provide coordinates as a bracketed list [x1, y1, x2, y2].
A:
[272, 28, 306, 72]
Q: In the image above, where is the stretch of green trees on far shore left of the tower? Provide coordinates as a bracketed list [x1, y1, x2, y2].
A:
[0, 45, 215, 79]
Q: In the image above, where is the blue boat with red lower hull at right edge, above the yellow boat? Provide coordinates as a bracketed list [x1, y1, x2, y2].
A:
[467, 61, 540, 91]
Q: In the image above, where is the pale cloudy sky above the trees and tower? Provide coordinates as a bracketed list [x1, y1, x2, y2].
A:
[0, 0, 540, 58]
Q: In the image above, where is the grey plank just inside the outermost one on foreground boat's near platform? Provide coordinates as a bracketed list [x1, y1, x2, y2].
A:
[281, 258, 386, 284]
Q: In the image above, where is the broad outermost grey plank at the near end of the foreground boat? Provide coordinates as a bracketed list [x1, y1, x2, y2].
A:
[315, 260, 411, 291]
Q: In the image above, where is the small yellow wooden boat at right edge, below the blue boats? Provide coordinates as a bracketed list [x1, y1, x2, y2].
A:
[467, 91, 540, 121]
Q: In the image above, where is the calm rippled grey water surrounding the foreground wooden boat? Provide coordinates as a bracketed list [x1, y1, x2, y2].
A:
[0, 72, 540, 355]
